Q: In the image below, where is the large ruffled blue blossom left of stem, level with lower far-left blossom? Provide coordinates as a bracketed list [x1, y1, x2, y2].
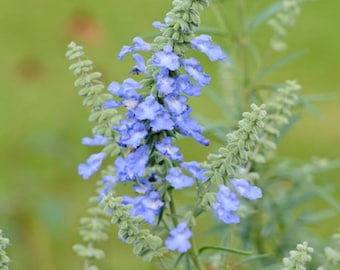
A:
[115, 145, 149, 182]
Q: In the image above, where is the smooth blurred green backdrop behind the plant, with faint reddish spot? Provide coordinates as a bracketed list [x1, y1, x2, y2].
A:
[0, 0, 340, 270]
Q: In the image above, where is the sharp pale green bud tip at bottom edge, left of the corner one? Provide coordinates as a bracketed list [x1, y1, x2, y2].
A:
[281, 242, 314, 270]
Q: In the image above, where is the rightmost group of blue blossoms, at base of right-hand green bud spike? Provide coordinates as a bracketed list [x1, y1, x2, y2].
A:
[213, 179, 262, 224]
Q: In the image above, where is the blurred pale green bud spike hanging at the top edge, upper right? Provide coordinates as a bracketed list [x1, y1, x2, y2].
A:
[268, 0, 300, 51]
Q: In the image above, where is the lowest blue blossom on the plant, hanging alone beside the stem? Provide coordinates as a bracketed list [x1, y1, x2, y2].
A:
[165, 222, 192, 253]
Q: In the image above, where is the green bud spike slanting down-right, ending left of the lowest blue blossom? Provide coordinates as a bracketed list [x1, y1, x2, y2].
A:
[102, 194, 168, 262]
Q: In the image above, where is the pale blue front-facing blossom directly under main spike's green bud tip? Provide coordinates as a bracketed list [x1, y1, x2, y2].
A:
[151, 45, 180, 71]
